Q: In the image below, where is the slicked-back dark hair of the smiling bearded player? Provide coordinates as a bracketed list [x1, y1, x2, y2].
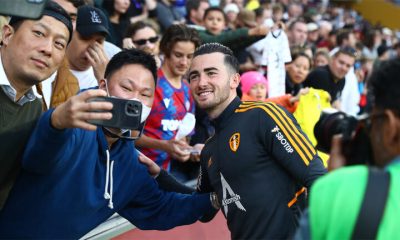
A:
[193, 43, 239, 73]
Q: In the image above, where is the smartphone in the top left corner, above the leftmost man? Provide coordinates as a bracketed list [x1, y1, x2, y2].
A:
[0, 0, 48, 19]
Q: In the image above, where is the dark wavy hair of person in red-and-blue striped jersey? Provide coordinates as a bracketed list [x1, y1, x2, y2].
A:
[160, 24, 201, 57]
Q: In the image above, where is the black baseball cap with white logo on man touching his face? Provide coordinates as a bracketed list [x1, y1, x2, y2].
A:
[76, 5, 110, 37]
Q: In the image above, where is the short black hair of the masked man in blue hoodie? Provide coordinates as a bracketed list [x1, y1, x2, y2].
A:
[104, 48, 157, 84]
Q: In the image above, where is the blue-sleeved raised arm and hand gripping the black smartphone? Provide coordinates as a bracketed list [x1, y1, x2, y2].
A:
[22, 90, 112, 173]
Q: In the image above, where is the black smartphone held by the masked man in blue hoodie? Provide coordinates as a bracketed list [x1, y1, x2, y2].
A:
[88, 97, 142, 129]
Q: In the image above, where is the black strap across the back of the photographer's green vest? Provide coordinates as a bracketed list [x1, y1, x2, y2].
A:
[352, 168, 390, 239]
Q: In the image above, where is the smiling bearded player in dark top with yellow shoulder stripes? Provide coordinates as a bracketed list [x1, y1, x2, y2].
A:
[189, 43, 326, 239]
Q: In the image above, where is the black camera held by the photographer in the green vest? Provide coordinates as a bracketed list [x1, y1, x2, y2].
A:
[314, 110, 373, 165]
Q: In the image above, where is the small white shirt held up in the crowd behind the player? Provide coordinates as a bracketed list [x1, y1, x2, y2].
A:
[261, 29, 292, 97]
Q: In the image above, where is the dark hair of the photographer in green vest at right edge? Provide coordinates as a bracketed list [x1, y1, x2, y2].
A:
[369, 59, 400, 113]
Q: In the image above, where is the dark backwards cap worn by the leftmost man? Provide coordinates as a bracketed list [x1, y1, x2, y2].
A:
[9, 1, 72, 43]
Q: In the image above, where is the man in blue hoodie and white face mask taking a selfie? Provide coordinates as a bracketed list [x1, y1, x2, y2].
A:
[0, 49, 213, 239]
